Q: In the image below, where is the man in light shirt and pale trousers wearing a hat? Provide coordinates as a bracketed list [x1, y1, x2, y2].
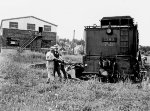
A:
[46, 47, 56, 83]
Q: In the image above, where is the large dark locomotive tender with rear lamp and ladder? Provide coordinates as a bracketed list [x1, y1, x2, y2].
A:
[82, 16, 140, 82]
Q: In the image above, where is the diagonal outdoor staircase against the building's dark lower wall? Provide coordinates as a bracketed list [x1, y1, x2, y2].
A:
[18, 35, 39, 52]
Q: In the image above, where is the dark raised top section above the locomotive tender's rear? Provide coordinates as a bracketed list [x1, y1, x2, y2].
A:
[100, 16, 134, 26]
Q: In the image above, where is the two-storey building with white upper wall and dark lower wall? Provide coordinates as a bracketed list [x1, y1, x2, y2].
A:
[0, 16, 57, 50]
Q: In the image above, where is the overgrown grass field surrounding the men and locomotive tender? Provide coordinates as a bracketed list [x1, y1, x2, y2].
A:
[0, 51, 150, 111]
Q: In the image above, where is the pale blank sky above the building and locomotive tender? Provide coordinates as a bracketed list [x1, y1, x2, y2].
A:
[0, 0, 150, 46]
